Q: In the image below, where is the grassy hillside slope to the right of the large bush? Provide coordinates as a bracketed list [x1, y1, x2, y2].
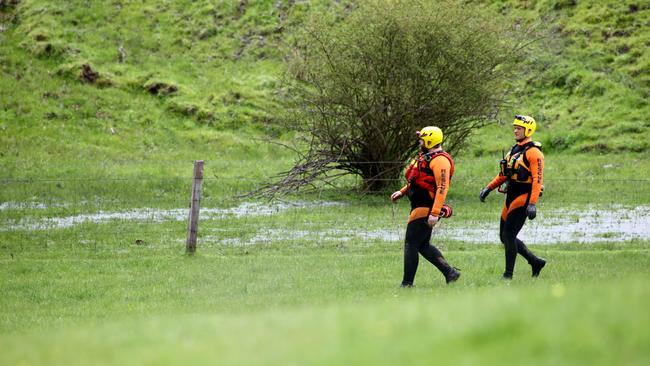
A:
[488, 0, 650, 153]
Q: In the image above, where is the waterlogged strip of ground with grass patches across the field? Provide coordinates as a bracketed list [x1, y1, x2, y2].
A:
[0, 202, 650, 246]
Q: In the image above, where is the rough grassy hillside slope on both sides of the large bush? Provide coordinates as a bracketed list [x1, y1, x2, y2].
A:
[0, 0, 650, 171]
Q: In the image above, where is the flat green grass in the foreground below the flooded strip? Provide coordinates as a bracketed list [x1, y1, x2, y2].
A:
[0, 244, 650, 365]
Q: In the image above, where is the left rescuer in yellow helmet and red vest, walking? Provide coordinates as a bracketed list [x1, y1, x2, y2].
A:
[390, 126, 460, 287]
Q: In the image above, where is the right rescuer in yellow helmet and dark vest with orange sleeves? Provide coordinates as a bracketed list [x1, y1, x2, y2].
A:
[479, 115, 546, 279]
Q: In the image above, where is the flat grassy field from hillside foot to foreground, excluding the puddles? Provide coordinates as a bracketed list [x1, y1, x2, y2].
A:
[0, 154, 650, 365]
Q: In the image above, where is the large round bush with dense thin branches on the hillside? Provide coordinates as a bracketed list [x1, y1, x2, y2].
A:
[274, 0, 535, 191]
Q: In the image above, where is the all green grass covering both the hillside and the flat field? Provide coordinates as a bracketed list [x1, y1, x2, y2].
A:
[0, 0, 650, 365]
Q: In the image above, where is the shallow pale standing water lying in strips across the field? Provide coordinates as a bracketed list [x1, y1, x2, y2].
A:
[0, 202, 650, 245]
